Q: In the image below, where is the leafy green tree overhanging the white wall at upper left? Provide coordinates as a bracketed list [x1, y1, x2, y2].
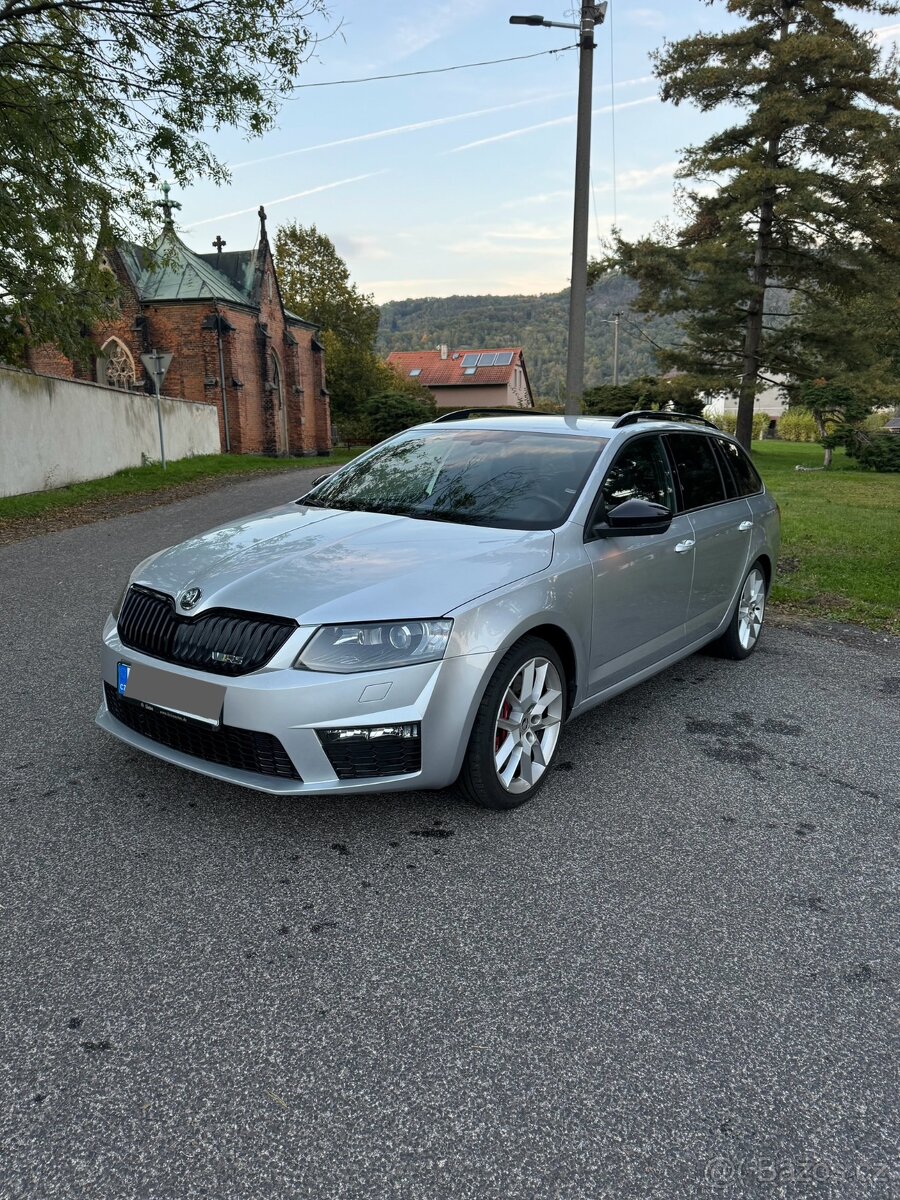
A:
[0, 0, 324, 356]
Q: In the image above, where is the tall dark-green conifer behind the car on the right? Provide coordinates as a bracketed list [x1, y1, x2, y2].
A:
[593, 0, 900, 445]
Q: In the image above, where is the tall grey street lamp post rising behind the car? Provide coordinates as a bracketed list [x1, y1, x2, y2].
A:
[509, 2, 606, 416]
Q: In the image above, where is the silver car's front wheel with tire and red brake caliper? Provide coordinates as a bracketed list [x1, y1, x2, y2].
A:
[458, 637, 566, 809]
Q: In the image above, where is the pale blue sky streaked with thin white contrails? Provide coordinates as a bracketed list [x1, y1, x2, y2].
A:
[173, 0, 900, 304]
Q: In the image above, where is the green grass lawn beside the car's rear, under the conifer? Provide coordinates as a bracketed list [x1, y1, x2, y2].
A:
[752, 442, 900, 634]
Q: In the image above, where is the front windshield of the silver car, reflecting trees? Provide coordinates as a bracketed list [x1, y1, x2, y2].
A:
[298, 430, 606, 529]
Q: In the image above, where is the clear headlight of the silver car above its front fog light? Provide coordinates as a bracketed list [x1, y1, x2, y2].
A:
[294, 620, 454, 673]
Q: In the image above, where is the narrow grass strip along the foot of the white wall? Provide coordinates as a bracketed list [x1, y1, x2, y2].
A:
[0, 450, 359, 522]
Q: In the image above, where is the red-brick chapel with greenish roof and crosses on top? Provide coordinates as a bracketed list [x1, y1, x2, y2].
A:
[29, 188, 331, 455]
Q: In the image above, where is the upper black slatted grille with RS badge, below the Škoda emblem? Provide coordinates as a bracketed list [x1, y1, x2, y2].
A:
[118, 586, 296, 676]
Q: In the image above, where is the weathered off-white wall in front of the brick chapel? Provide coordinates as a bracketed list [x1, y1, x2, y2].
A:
[0, 367, 220, 496]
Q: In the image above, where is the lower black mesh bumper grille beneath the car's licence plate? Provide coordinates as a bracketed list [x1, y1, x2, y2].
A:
[103, 683, 302, 782]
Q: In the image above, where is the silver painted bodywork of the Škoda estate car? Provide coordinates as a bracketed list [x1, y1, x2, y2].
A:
[97, 416, 779, 794]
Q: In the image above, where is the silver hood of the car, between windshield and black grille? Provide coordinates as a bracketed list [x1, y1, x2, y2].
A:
[132, 504, 553, 624]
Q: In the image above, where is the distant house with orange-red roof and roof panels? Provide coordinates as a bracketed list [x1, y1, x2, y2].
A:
[388, 346, 534, 408]
